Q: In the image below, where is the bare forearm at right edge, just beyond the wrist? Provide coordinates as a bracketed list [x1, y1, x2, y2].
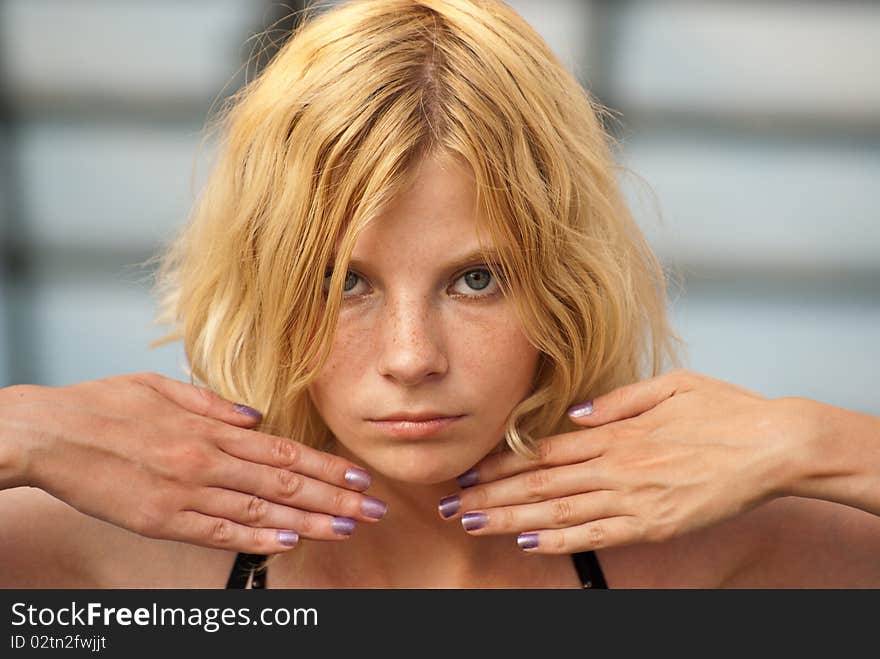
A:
[782, 398, 880, 515]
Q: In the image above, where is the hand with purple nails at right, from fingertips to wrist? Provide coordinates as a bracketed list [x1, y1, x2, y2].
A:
[440, 369, 810, 554]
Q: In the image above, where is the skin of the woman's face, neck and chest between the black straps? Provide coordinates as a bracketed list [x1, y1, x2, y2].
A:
[273, 158, 577, 587]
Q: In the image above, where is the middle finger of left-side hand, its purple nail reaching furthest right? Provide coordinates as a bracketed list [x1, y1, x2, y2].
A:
[210, 458, 387, 522]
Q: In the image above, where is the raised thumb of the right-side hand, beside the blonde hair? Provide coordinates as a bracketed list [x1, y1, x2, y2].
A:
[568, 369, 694, 427]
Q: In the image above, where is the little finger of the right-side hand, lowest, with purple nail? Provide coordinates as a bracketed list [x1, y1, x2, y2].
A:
[516, 515, 643, 554]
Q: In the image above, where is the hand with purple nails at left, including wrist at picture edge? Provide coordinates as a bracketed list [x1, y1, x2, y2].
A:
[0, 373, 386, 554]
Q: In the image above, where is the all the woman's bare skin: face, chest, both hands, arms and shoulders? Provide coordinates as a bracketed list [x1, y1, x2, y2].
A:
[0, 153, 880, 588]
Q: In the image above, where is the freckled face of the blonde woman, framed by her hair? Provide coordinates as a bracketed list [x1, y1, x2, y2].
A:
[309, 159, 538, 484]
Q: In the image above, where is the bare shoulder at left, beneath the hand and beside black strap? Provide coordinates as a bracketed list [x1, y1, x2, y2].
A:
[0, 487, 235, 588]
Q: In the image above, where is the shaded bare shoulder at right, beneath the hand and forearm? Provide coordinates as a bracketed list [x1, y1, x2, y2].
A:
[596, 497, 880, 588]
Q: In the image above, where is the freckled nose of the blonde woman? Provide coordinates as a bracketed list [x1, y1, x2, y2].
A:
[378, 304, 449, 386]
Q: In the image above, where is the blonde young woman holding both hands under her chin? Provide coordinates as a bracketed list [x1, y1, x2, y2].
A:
[0, 0, 880, 588]
